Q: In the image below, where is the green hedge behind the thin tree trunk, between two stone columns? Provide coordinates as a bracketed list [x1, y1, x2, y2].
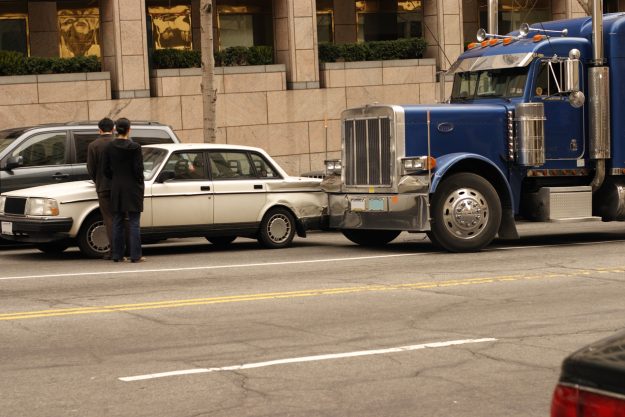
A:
[152, 46, 273, 69]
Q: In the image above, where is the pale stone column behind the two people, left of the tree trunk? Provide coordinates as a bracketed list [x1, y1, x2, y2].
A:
[100, 0, 150, 98]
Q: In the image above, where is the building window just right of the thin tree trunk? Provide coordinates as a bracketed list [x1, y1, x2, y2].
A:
[217, 0, 273, 50]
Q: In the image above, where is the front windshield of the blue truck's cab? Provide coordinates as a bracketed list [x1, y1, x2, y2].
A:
[451, 67, 528, 103]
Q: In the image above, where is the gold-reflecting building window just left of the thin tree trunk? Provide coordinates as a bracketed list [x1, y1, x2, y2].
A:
[147, 1, 193, 50]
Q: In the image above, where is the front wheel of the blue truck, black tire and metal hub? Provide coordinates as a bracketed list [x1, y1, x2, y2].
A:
[428, 173, 501, 252]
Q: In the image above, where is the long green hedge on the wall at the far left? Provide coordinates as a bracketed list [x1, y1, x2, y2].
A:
[0, 51, 101, 75]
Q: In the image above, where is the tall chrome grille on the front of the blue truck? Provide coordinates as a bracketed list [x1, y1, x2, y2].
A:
[343, 117, 392, 187]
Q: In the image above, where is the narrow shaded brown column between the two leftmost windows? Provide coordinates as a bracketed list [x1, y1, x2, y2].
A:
[28, 1, 59, 57]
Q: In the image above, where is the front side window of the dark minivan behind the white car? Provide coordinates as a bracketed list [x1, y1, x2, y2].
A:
[11, 132, 67, 167]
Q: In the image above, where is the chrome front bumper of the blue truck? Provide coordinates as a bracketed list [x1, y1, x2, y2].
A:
[329, 193, 430, 232]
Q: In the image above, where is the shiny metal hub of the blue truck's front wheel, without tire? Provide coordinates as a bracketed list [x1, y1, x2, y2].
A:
[443, 188, 488, 239]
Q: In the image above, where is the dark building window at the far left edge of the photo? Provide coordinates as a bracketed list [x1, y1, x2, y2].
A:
[0, 1, 29, 55]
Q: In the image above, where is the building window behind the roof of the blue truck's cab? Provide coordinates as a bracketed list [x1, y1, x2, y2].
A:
[479, 0, 551, 34]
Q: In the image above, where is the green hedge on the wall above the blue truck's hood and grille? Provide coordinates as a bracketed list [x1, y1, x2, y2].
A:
[319, 38, 427, 62]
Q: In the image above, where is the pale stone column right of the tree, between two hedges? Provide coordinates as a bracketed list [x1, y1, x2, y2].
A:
[273, 0, 319, 90]
